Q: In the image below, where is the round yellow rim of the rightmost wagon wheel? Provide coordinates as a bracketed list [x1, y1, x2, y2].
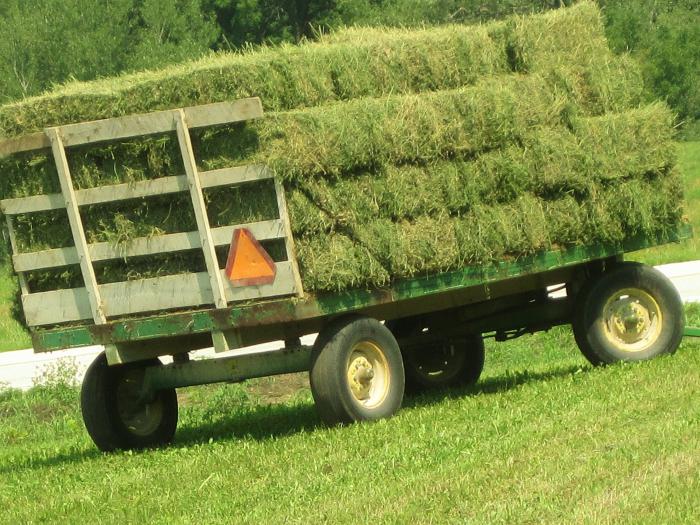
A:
[603, 288, 663, 352]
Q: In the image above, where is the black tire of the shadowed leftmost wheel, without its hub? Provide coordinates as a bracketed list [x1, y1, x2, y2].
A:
[80, 352, 178, 452]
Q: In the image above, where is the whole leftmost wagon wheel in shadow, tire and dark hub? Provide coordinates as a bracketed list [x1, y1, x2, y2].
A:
[80, 352, 178, 452]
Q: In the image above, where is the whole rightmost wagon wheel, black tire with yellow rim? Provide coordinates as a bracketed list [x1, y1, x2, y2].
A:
[573, 263, 684, 365]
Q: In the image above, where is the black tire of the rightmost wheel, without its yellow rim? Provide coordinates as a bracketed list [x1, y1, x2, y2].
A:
[572, 262, 684, 366]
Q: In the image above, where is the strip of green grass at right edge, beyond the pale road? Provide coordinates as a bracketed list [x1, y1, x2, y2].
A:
[629, 142, 700, 265]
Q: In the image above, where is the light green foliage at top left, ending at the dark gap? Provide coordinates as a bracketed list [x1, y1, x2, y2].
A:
[0, 0, 219, 100]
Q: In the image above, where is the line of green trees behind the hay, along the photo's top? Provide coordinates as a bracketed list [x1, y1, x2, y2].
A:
[0, 0, 700, 128]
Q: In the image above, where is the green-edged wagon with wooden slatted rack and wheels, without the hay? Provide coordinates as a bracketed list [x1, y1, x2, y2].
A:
[0, 98, 690, 450]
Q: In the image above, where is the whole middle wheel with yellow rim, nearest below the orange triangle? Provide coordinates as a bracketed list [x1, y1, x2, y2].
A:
[310, 316, 404, 424]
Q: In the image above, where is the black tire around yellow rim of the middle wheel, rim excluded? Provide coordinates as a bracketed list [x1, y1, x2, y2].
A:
[309, 316, 404, 425]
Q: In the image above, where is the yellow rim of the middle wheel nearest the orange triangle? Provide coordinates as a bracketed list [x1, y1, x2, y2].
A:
[347, 341, 391, 408]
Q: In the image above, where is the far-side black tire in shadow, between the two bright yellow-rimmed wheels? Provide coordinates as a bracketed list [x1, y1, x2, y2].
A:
[385, 317, 486, 394]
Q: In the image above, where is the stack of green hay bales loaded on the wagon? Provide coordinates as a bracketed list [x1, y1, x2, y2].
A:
[0, 1, 681, 298]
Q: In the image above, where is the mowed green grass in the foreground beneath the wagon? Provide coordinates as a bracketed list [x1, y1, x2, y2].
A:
[0, 328, 700, 524]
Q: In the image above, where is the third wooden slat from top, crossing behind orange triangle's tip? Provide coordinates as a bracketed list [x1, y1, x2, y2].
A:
[12, 219, 285, 272]
